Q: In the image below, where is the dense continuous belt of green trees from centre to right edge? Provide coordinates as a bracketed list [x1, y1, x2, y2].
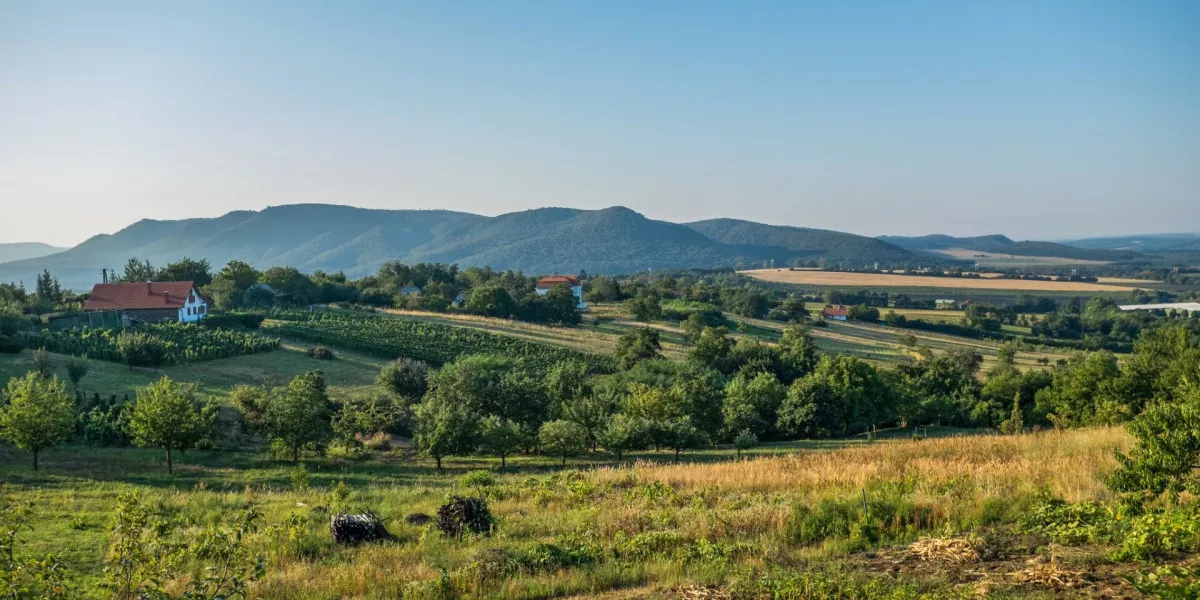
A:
[415, 326, 1200, 464]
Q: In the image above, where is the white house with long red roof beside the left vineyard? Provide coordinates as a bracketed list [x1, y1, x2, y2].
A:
[83, 281, 209, 324]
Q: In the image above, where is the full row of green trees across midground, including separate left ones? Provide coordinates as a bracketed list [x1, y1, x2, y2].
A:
[7, 326, 1200, 468]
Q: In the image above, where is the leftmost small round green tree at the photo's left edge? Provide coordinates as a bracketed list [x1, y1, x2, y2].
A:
[0, 371, 74, 470]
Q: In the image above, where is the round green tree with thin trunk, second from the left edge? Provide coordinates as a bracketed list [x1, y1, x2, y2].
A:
[128, 376, 216, 473]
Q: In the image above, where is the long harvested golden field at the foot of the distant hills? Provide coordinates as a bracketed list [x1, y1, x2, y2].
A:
[740, 269, 1134, 292]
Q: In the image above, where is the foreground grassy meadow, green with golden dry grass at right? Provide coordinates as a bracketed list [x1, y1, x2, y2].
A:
[0, 430, 1152, 600]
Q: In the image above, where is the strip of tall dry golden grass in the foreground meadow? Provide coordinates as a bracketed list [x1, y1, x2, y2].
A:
[596, 427, 1130, 502]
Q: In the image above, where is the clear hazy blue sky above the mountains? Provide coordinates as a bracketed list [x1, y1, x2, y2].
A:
[0, 0, 1200, 245]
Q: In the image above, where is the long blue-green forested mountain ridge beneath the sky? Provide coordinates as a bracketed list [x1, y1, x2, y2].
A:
[0, 204, 935, 289]
